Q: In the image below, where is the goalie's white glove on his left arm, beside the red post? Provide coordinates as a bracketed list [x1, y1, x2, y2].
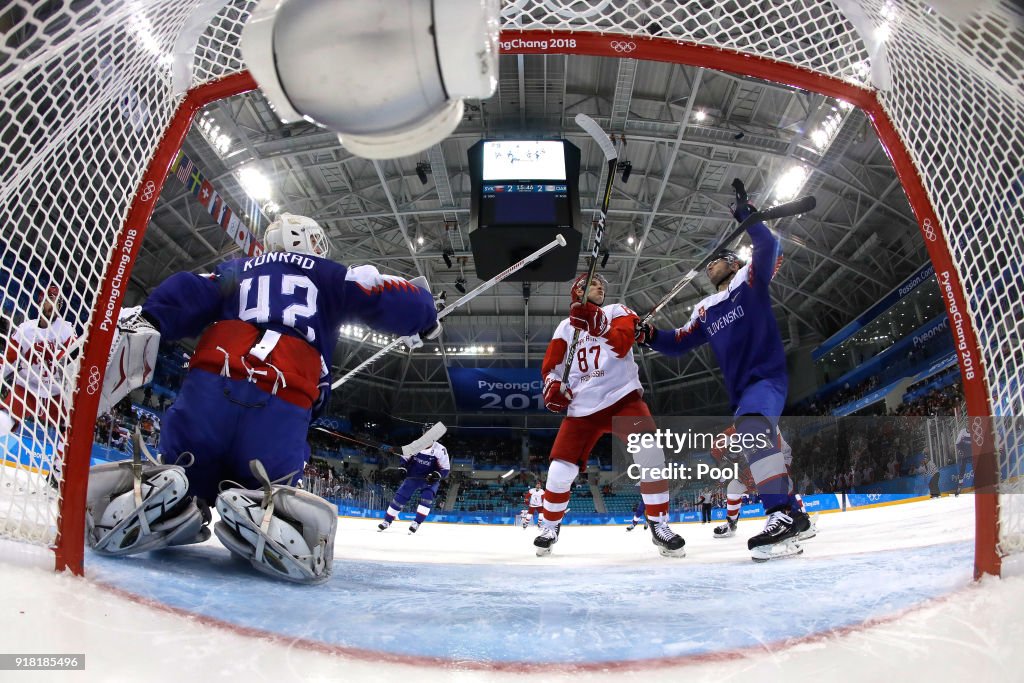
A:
[98, 306, 160, 414]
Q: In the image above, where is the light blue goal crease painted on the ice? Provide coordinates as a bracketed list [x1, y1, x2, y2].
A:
[87, 541, 973, 664]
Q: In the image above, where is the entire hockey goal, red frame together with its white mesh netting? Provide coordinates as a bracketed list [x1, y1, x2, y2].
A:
[0, 0, 1024, 572]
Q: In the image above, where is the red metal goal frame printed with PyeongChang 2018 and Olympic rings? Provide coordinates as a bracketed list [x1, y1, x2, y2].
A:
[54, 30, 1000, 579]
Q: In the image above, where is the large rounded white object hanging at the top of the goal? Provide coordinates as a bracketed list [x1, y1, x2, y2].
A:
[241, 0, 499, 159]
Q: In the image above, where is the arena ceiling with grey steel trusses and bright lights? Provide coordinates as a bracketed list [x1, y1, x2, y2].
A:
[133, 55, 927, 425]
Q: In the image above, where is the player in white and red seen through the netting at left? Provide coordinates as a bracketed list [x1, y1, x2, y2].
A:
[0, 285, 75, 487]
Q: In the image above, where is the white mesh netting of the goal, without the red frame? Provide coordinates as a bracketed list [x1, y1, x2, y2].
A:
[0, 0, 1024, 565]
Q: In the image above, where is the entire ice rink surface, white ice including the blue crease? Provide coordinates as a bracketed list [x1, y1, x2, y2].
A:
[0, 496, 1024, 681]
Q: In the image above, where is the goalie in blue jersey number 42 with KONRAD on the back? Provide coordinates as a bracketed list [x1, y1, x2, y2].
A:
[87, 214, 439, 584]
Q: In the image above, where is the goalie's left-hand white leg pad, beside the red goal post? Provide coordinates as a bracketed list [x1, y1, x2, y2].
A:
[85, 463, 210, 556]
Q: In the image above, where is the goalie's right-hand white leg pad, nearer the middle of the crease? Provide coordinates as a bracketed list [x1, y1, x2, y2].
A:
[214, 485, 338, 584]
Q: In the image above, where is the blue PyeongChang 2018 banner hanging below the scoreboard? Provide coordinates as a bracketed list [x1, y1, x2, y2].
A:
[449, 368, 544, 413]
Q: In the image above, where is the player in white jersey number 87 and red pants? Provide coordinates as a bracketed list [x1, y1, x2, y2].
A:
[534, 273, 686, 557]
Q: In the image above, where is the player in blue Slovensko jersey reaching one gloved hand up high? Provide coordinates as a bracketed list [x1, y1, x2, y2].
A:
[637, 178, 810, 561]
